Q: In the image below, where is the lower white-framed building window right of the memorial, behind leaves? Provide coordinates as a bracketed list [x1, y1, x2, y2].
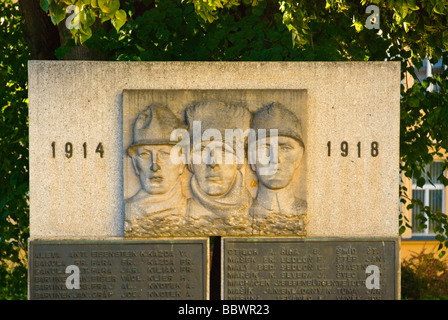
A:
[412, 162, 446, 236]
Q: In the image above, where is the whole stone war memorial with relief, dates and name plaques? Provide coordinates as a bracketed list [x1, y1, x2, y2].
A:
[29, 61, 400, 300]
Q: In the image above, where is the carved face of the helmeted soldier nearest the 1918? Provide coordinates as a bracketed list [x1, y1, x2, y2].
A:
[251, 136, 304, 189]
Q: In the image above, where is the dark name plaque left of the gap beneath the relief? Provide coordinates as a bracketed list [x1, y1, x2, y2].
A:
[29, 239, 209, 300]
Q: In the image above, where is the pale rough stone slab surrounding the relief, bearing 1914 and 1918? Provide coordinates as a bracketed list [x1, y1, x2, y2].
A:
[29, 61, 400, 239]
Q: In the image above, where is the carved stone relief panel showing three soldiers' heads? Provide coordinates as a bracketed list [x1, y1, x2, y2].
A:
[123, 90, 307, 237]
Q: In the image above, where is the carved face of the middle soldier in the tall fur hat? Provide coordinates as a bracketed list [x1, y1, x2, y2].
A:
[192, 142, 240, 196]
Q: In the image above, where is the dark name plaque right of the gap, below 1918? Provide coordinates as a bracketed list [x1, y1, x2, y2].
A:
[221, 238, 399, 300]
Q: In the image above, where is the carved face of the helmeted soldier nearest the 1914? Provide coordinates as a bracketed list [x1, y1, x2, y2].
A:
[132, 145, 184, 195]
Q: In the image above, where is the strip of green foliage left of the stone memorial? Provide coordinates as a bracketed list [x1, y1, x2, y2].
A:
[0, 0, 29, 299]
